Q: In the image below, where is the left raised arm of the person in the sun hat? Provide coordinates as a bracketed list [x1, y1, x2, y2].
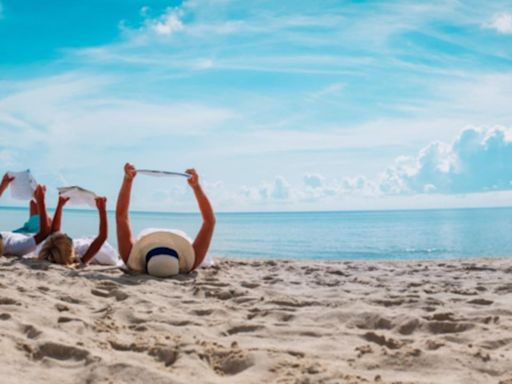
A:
[116, 163, 137, 263]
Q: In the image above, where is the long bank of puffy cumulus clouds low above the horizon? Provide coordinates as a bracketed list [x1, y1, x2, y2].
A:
[228, 127, 512, 206]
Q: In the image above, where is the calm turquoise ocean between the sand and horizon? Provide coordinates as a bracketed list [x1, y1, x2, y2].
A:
[0, 208, 512, 260]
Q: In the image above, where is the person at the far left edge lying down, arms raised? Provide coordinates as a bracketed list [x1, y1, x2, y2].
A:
[0, 174, 50, 256]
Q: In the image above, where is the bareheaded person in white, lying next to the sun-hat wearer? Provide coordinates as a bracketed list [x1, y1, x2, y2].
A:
[38, 196, 120, 266]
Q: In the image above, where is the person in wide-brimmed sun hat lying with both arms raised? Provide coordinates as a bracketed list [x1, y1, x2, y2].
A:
[116, 163, 215, 277]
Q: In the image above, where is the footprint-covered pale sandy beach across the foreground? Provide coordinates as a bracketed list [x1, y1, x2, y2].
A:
[0, 257, 512, 384]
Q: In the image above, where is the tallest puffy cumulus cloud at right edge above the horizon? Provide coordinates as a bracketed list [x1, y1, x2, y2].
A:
[379, 128, 512, 194]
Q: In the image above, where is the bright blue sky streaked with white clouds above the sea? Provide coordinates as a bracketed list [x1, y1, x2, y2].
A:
[0, 0, 512, 211]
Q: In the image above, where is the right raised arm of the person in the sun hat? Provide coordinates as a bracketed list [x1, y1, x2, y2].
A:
[186, 169, 215, 271]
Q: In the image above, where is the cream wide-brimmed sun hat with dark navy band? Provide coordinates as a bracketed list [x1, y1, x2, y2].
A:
[127, 229, 195, 277]
